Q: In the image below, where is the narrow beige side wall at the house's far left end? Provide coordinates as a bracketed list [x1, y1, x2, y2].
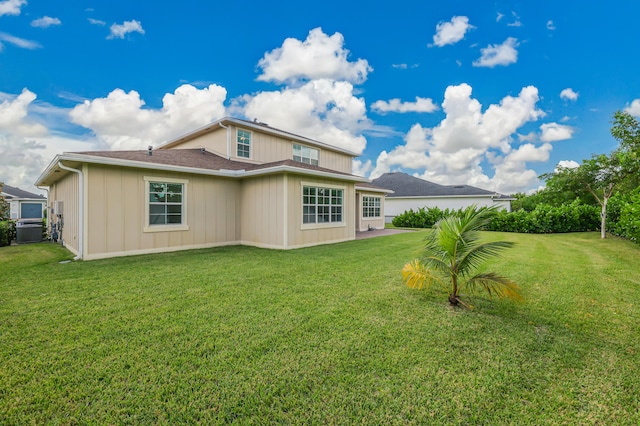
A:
[47, 172, 80, 255]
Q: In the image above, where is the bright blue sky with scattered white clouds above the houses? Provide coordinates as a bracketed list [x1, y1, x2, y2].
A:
[0, 0, 640, 193]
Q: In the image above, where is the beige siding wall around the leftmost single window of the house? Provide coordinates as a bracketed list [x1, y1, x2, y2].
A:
[84, 164, 240, 260]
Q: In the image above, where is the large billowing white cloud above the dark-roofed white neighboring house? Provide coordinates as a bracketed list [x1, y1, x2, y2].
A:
[368, 84, 552, 193]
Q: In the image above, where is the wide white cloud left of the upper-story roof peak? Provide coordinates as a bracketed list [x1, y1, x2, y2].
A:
[69, 84, 227, 150]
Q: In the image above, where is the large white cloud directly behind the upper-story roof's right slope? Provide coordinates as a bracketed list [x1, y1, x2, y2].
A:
[234, 79, 369, 154]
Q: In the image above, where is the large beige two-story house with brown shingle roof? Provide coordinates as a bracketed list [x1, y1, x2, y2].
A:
[37, 118, 390, 260]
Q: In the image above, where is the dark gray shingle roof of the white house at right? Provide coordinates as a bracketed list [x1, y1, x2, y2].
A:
[372, 172, 509, 198]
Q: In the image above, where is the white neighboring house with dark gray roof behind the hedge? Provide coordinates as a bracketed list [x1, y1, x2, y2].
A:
[372, 173, 514, 223]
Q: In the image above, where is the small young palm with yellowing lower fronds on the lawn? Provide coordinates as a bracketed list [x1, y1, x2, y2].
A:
[402, 205, 522, 307]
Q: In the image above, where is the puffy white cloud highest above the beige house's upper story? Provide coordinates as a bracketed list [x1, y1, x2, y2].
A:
[258, 28, 372, 84]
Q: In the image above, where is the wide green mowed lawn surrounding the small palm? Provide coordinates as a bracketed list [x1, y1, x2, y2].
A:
[0, 235, 640, 425]
